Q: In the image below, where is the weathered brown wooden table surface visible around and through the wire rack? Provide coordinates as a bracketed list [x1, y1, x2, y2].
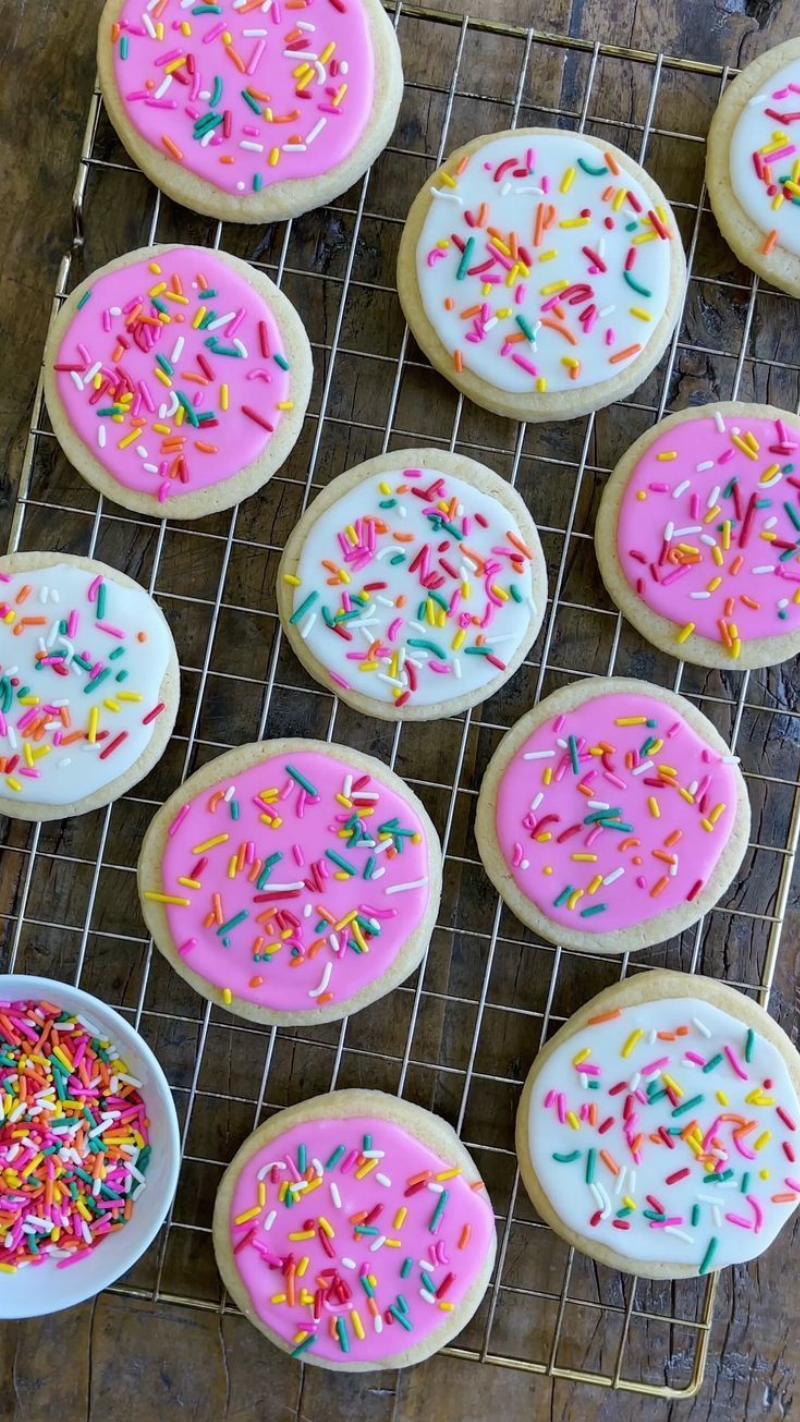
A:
[0, 0, 800, 1422]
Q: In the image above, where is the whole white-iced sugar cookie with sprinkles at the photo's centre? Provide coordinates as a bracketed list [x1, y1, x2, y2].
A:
[277, 449, 547, 721]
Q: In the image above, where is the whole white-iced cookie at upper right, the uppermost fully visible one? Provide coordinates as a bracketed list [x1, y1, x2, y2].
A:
[398, 128, 686, 421]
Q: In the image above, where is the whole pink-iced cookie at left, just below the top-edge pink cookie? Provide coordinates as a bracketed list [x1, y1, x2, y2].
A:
[44, 246, 311, 519]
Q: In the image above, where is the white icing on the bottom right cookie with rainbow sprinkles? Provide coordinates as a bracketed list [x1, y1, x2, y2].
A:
[529, 998, 800, 1268]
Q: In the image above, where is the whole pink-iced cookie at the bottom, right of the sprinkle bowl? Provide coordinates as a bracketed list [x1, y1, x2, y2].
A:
[213, 1091, 496, 1372]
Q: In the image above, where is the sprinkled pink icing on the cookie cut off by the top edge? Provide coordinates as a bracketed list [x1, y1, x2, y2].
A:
[112, 0, 375, 196]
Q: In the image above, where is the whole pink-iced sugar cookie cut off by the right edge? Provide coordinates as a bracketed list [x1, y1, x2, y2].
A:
[595, 404, 800, 667]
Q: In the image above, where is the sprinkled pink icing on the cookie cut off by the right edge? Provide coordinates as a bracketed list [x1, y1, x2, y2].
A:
[617, 414, 800, 657]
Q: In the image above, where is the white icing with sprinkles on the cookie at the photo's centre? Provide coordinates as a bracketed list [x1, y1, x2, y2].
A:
[293, 464, 534, 705]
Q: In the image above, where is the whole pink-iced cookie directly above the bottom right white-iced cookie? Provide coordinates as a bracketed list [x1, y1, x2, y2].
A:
[475, 677, 750, 953]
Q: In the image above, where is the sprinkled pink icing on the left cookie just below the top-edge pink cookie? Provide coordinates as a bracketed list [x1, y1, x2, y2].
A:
[54, 247, 294, 503]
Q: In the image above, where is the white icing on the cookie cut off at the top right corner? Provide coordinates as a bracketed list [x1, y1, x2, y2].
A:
[730, 60, 800, 255]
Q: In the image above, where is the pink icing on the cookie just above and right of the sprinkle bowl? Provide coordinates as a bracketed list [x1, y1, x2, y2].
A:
[154, 751, 429, 1014]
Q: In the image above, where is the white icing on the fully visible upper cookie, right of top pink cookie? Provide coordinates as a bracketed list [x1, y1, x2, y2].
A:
[416, 131, 679, 394]
